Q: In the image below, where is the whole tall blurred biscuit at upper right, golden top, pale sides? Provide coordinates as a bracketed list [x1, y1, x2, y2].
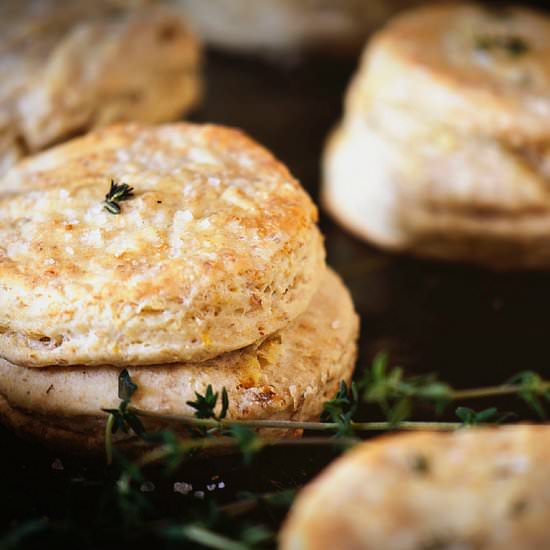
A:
[323, 3, 550, 269]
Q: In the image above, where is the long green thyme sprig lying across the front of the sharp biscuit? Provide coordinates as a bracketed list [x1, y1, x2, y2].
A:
[105, 354, 550, 470]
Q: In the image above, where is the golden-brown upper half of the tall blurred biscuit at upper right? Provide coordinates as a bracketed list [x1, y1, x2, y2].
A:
[358, 2, 550, 141]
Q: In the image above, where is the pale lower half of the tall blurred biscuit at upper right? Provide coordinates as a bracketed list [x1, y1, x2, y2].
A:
[322, 118, 550, 269]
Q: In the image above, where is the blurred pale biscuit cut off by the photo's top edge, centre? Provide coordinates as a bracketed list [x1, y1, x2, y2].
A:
[175, 0, 421, 53]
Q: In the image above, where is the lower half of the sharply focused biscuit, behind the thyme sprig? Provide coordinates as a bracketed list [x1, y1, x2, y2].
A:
[0, 270, 359, 452]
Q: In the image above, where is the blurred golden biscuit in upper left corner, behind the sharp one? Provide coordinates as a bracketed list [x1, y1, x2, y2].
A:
[0, 0, 200, 174]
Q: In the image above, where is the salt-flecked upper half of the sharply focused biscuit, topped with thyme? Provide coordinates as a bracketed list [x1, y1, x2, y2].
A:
[0, 123, 324, 367]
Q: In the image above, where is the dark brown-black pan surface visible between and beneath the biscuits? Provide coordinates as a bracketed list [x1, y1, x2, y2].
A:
[0, 3, 550, 548]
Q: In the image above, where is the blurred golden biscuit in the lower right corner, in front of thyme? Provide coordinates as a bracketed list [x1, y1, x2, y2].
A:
[280, 425, 550, 550]
